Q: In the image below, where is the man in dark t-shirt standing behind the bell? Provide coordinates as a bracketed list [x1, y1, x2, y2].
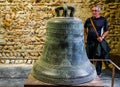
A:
[84, 5, 109, 75]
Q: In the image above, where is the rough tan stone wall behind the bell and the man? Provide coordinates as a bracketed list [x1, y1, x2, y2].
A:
[0, 0, 120, 63]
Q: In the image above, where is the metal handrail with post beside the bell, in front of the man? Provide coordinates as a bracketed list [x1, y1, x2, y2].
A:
[90, 59, 120, 87]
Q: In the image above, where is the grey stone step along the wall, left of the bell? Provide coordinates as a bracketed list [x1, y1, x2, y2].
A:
[0, 64, 32, 78]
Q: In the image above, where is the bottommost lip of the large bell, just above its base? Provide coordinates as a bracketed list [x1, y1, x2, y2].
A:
[32, 72, 96, 85]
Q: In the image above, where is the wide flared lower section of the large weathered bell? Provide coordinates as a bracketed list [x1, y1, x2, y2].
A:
[31, 59, 97, 85]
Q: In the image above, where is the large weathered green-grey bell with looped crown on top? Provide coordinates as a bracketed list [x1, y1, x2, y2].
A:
[31, 6, 96, 85]
